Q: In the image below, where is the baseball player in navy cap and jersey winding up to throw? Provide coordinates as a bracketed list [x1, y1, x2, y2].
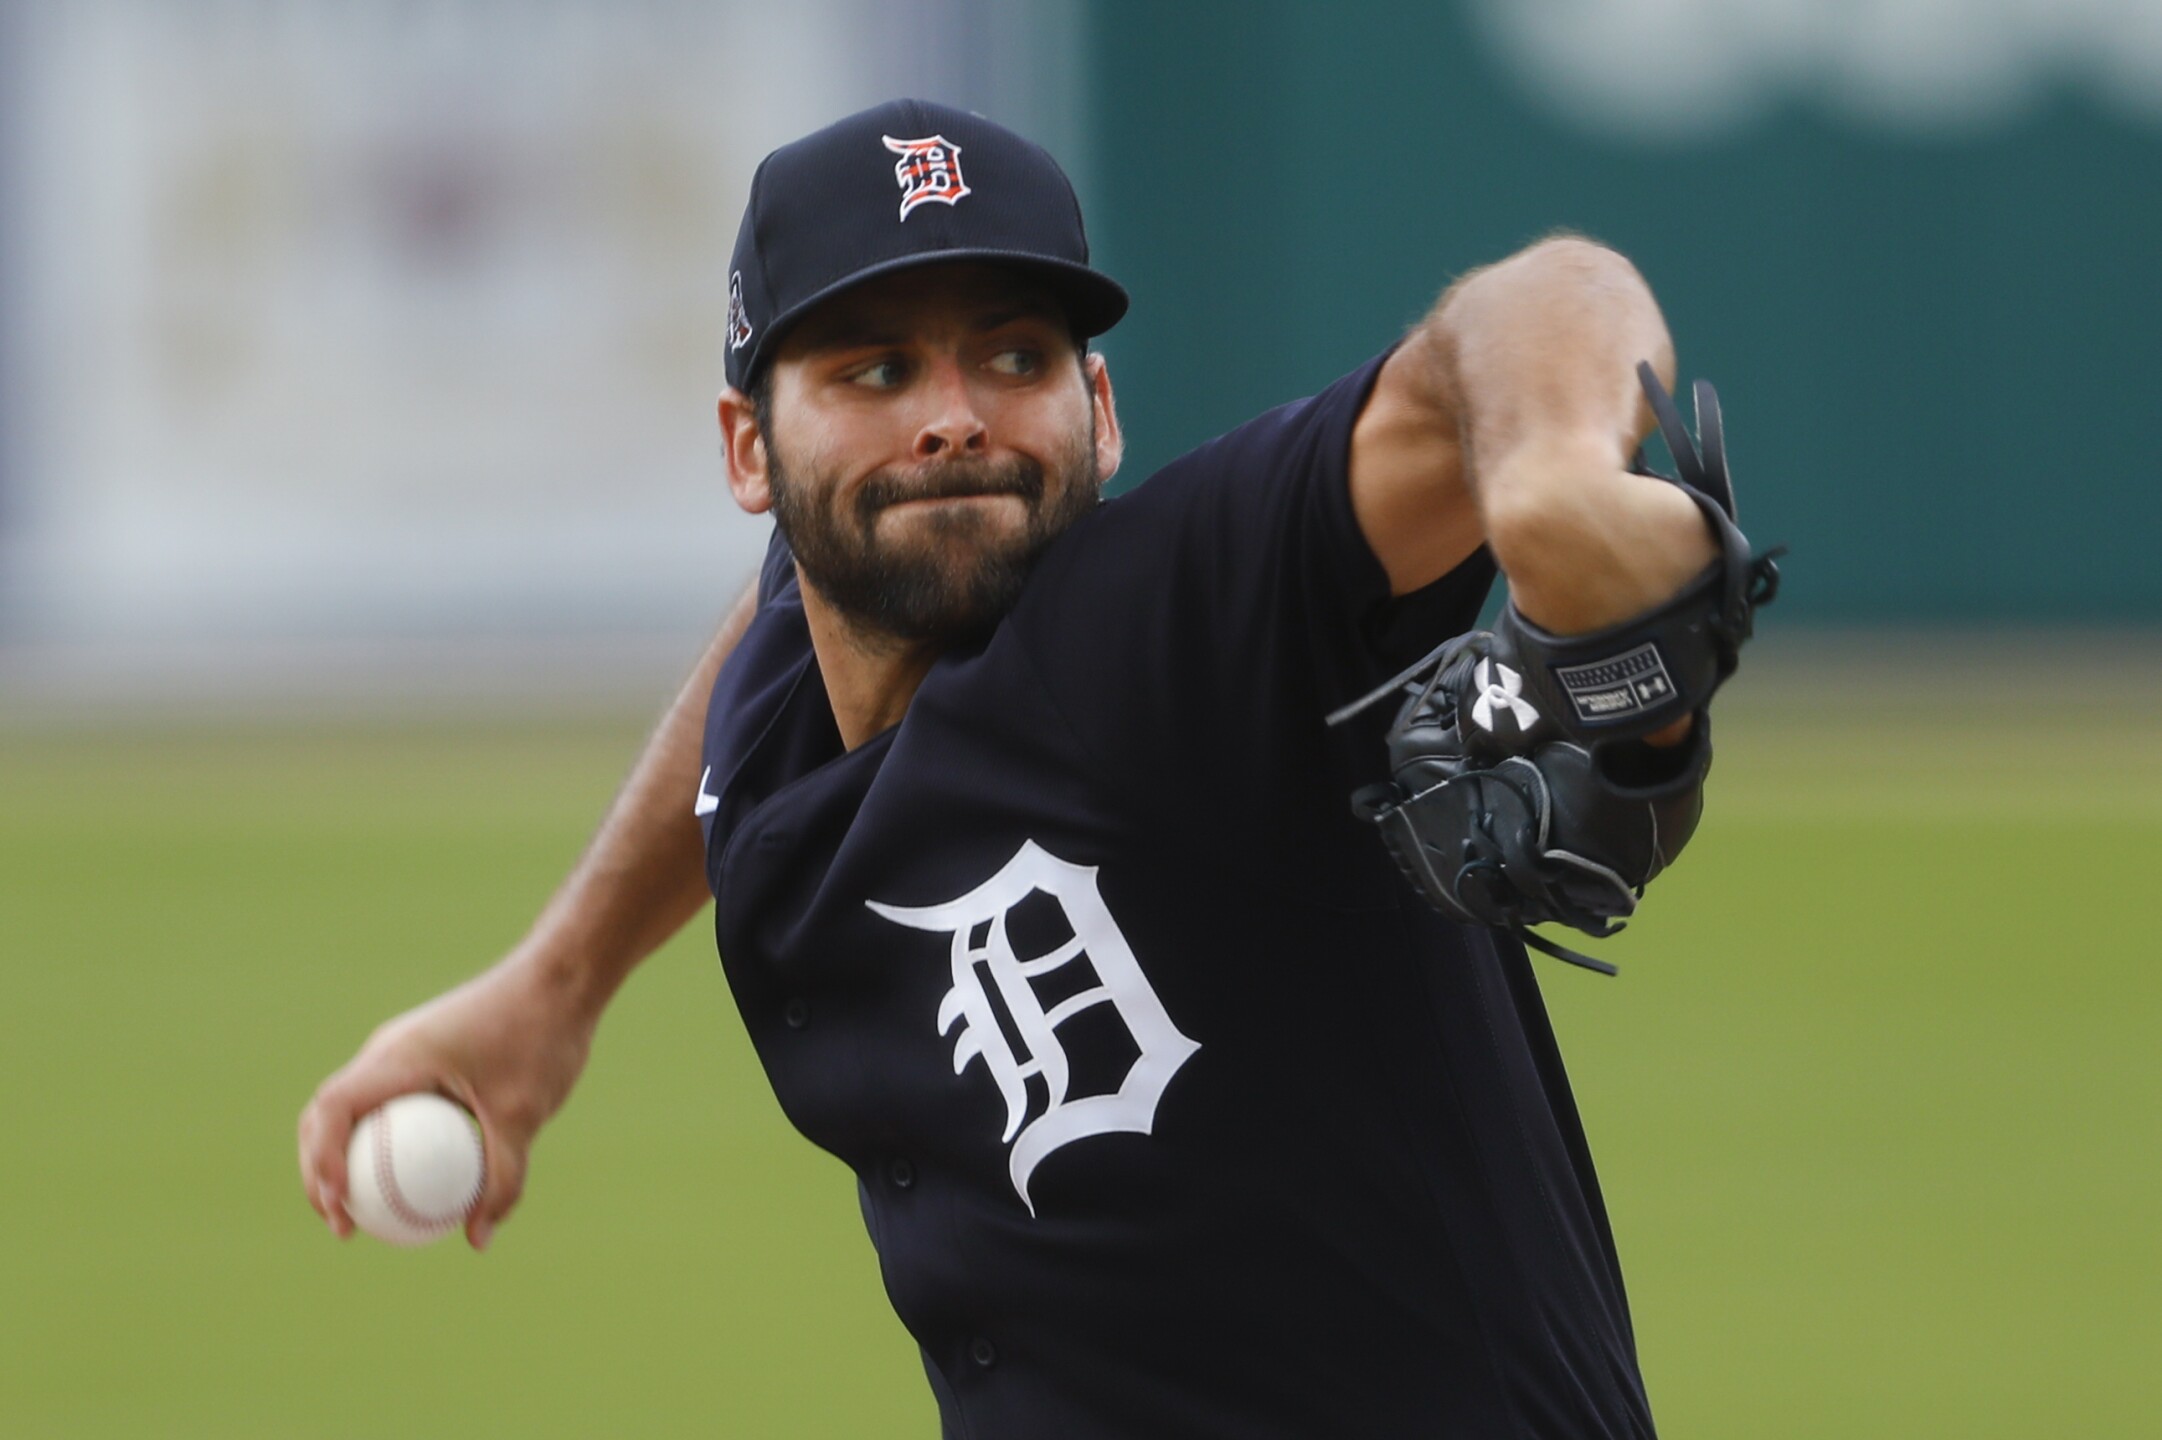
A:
[301, 102, 1771, 1440]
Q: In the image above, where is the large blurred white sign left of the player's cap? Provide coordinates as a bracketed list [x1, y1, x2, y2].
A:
[0, 0, 1077, 661]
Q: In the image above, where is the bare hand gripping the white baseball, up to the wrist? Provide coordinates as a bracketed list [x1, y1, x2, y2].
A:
[301, 958, 599, 1250]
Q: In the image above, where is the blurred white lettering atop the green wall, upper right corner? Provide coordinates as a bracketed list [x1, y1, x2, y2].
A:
[1472, 0, 2162, 141]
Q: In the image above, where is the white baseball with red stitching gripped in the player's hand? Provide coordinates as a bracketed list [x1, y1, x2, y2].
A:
[346, 1094, 486, 1245]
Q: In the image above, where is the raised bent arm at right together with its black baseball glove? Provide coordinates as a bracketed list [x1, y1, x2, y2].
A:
[1334, 238, 1779, 971]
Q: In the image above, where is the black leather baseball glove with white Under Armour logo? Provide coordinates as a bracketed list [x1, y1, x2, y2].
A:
[1330, 365, 1781, 975]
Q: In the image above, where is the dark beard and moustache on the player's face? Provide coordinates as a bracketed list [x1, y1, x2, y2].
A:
[765, 415, 1103, 644]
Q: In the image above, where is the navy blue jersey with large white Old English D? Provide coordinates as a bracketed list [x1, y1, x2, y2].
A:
[700, 361, 1652, 1440]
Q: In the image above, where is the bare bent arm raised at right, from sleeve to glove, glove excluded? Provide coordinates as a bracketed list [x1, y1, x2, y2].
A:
[1351, 236, 1714, 634]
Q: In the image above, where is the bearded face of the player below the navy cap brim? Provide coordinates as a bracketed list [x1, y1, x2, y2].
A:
[739, 264, 1118, 644]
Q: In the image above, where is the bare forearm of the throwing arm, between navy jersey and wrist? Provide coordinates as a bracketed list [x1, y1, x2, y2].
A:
[506, 590, 755, 1014]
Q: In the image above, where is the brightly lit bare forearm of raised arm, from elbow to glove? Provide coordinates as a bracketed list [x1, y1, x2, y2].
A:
[1425, 238, 1712, 634]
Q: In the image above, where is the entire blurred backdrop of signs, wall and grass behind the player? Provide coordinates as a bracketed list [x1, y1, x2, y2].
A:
[0, 0, 2162, 1436]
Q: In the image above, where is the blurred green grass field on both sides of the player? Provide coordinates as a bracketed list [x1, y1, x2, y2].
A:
[0, 655, 2162, 1440]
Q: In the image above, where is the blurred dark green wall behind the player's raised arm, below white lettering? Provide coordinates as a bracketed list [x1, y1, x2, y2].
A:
[1090, 0, 2162, 623]
